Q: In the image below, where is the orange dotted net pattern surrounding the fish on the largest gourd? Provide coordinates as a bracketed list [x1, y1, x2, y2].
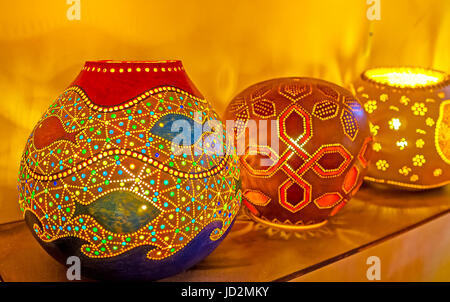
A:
[18, 85, 241, 260]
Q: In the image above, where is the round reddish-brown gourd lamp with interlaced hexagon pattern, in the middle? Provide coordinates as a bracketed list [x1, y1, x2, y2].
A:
[224, 78, 371, 230]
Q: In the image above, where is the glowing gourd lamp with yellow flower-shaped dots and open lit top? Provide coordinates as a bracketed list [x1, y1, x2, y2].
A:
[353, 67, 450, 190]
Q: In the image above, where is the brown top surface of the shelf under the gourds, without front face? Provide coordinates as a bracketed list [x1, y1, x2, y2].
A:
[0, 185, 450, 282]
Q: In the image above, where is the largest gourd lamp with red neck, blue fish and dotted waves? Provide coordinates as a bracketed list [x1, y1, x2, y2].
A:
[18, 61, 241, 280]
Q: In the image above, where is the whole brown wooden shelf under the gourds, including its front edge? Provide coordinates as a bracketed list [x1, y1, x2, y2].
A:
[0, 186, 450, 281]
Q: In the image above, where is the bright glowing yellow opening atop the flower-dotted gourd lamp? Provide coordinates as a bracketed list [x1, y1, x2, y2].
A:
[364, 67, 447, 88]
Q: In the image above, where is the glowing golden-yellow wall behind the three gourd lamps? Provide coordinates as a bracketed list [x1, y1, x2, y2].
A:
[0, 0, 450, 223]
